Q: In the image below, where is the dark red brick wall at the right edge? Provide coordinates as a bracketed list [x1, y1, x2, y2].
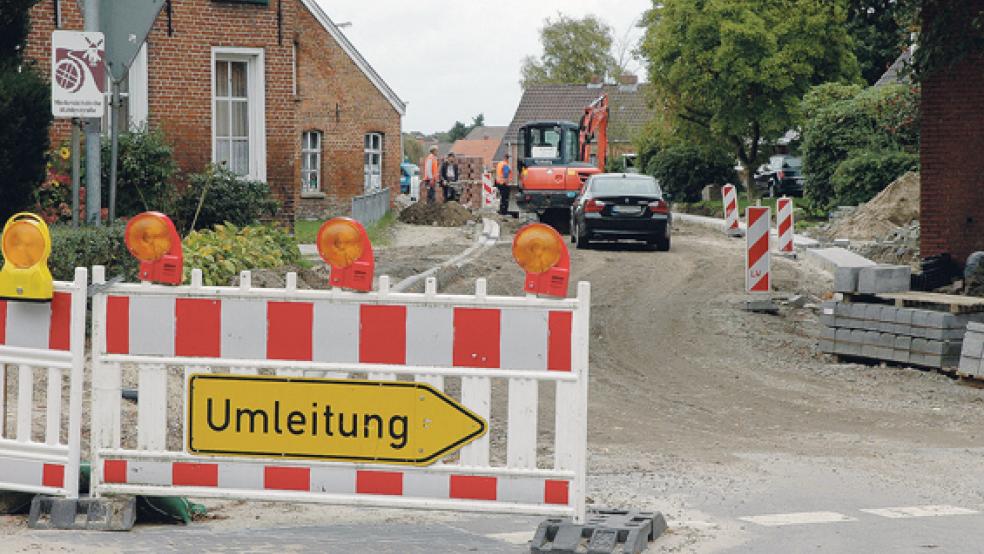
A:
[920, 0, 984, 263]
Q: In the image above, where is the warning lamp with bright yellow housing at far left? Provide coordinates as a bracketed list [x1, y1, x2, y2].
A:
[0, 213, 55, 302]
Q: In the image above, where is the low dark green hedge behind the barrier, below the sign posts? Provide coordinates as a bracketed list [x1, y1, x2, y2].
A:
[48, 223, 137, 281]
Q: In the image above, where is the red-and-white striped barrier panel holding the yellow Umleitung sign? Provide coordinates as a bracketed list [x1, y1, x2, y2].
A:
[92, 267, 590, 521]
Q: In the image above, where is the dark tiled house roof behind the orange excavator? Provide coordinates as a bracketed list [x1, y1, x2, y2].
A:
[495, 84, 653, 160]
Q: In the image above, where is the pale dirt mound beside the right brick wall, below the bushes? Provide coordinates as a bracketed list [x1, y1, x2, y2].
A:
[824, 172, 919, 240]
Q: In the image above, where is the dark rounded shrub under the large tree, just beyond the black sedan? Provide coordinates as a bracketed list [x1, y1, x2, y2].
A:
[646, 145, 737, 202]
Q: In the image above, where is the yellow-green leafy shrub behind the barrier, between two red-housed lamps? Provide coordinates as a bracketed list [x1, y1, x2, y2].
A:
[182, 223, 302, 285]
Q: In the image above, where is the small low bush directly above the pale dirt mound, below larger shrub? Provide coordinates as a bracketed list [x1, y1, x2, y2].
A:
[830, 150, 919, 205]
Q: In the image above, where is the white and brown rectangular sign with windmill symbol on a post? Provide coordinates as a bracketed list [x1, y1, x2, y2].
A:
[51, 31, 106, 117]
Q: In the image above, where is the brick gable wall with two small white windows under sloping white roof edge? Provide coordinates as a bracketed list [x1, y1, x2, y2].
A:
[296, 6, 402, 217]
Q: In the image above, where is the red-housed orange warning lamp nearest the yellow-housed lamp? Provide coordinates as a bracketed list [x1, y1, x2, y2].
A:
[126, 212, 184, 285]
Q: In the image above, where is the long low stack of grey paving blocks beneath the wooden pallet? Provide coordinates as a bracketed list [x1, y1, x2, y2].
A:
[820, 302, 984, 369]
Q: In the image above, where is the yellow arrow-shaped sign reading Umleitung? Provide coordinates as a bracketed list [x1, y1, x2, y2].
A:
[188, 374, 487, 465]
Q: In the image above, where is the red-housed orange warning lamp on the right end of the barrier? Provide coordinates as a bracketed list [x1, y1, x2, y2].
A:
[513, 223, 571, 298]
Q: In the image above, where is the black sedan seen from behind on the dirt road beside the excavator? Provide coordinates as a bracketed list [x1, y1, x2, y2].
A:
[571, 173, 672, 251]
